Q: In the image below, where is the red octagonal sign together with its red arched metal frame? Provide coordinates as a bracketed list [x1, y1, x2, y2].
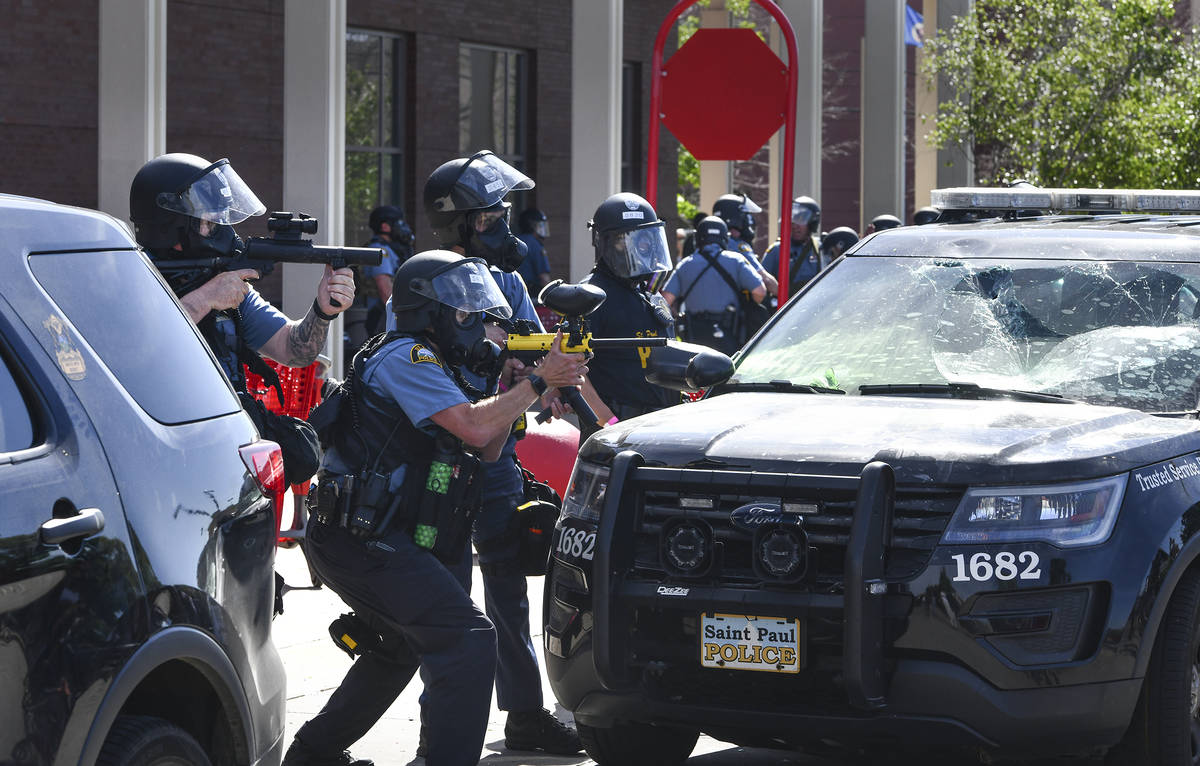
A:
[646, 0, 799, 306]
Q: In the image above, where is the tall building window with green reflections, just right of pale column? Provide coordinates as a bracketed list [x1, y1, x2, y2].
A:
[346, 30, 406, 245]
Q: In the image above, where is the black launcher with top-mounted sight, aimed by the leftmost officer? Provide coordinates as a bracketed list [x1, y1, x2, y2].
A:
[155, 213, 383, 309]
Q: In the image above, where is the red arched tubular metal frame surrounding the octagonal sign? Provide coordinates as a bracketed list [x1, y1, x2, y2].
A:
[646, 0, 799, 306]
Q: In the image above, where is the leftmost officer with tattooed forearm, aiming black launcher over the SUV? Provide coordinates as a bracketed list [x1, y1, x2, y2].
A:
[130, 154, 354, 391]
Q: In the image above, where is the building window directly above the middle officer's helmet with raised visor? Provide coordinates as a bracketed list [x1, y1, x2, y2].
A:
[458, 44, 529, 173]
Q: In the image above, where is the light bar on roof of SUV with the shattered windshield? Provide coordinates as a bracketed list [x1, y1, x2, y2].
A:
[930, 186, 1200, 213]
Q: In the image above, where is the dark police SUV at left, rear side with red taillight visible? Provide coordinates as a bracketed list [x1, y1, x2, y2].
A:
[0, 195, 286, 766]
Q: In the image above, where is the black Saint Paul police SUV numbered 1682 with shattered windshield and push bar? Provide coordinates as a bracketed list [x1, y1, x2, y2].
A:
[545, 188, 1200, 766]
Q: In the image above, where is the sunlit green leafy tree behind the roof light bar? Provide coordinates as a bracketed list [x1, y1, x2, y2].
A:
[923, 0, 1200, 188]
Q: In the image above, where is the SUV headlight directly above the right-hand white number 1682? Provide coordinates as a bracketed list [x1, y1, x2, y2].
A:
[942, 475, 1128, 546]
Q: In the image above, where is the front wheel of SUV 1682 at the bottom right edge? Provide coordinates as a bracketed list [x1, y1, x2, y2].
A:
[1108, 569, 1200, 766]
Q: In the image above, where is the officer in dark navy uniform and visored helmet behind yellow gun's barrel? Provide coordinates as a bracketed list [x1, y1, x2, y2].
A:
[583, 192, 679, 420]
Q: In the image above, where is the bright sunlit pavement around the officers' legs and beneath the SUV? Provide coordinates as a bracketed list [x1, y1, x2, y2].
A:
[274, 547, 1099, 766]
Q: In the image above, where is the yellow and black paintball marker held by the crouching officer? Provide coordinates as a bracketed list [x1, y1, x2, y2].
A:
[508, 280, 667, 438]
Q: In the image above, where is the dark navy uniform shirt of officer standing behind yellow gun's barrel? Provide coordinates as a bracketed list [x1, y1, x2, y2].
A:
[583, 269, 679, 409]
